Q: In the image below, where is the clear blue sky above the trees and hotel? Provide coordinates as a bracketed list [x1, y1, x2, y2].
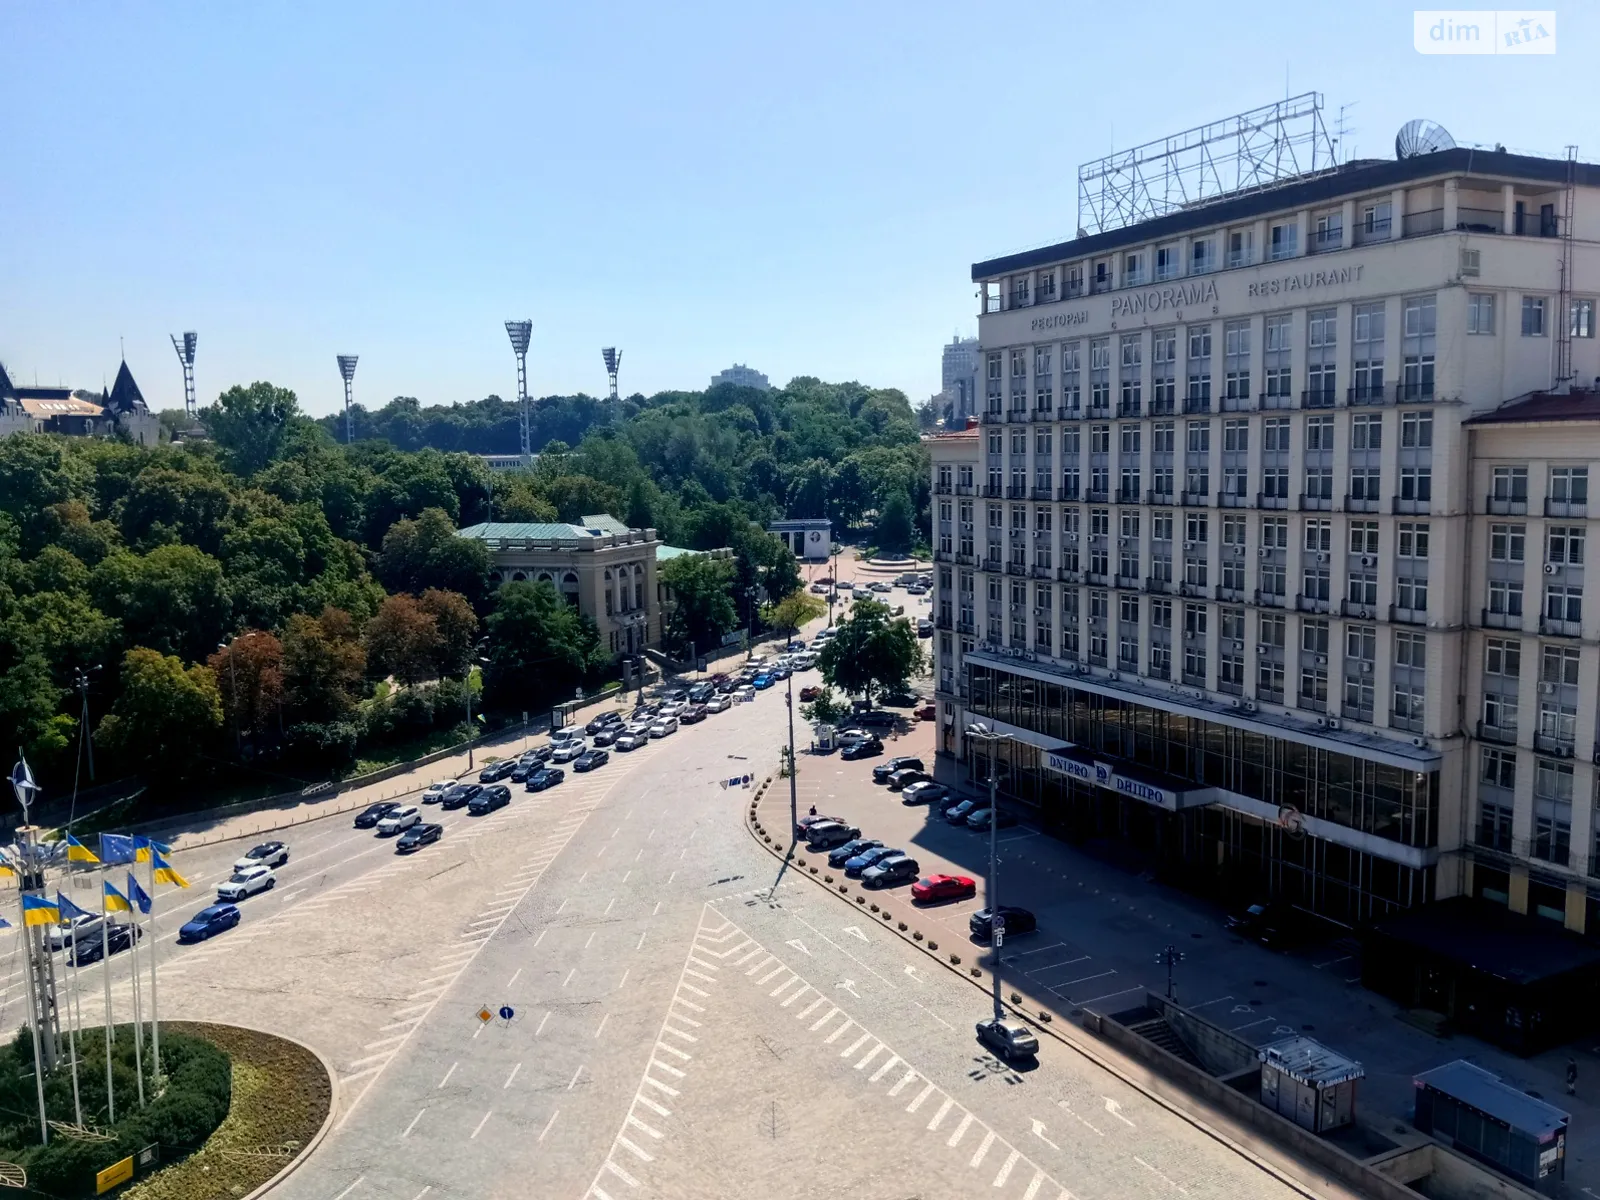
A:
[0, 0, 1600, 413]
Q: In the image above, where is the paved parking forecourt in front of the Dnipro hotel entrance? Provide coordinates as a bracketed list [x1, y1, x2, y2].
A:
[762, 722, 1600, 1200]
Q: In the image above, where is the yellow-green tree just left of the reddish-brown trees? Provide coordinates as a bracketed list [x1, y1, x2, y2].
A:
[96, 646, 222, 778]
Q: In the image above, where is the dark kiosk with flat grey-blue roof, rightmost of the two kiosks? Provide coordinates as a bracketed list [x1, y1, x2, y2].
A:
[1413, 1059, 1571, 1187]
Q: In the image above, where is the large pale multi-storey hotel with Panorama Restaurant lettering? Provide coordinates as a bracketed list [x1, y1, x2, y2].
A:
[926, 149, 1600, 933]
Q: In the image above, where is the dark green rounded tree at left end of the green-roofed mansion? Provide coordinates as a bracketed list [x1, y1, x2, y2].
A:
[483, 581, 606, 709]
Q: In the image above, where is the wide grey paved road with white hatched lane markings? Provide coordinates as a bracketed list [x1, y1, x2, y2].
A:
[0, 569, 1324, 1200]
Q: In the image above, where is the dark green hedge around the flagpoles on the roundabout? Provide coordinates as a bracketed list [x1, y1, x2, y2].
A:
[0, 1022, 234, 1197]
